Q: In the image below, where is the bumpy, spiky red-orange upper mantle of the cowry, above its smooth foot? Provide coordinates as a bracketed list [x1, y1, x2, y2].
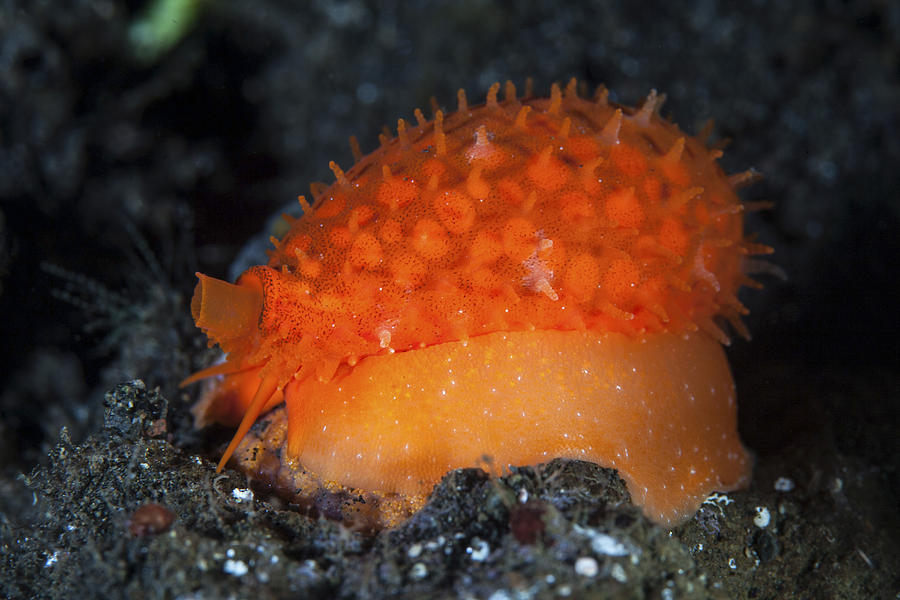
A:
[195, 79, 748, 383]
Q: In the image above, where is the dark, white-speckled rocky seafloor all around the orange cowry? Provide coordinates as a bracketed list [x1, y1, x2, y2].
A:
[0, 0, 900, 600]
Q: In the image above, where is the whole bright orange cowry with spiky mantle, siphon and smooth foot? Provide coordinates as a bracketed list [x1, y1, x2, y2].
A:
[186, 80, 771, 526]
